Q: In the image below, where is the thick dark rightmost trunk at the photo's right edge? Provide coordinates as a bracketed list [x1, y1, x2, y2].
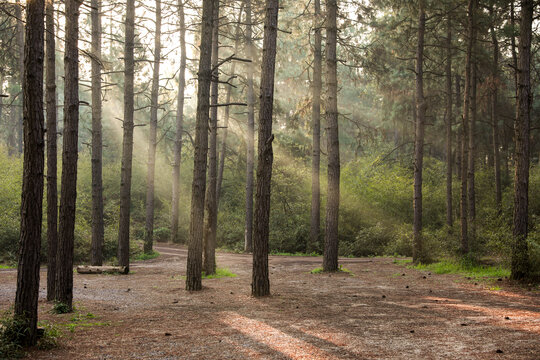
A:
[512, 0, 534, 280]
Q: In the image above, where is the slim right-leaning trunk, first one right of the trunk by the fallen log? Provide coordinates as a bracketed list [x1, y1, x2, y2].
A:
[144, 0, 161, 254]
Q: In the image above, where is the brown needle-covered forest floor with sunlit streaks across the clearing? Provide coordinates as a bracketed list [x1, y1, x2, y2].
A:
[0, 244, 540, 360]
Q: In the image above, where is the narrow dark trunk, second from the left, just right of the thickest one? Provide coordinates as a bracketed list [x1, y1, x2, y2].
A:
[45, 0, 58, 301]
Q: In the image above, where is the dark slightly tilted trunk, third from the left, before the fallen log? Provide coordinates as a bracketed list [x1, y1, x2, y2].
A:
[56, 0, 81, 311]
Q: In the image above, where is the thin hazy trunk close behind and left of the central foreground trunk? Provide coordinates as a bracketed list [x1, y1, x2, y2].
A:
[244, 0, 255, 252]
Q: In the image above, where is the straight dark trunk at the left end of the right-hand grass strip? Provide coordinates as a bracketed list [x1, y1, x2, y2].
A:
[413, 0, 427, 263]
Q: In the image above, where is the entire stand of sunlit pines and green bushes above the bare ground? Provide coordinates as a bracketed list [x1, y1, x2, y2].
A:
[0, 0, 540, 344]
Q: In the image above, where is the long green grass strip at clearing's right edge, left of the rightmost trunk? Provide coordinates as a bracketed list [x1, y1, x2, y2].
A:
[408, 261, 510, 278]
